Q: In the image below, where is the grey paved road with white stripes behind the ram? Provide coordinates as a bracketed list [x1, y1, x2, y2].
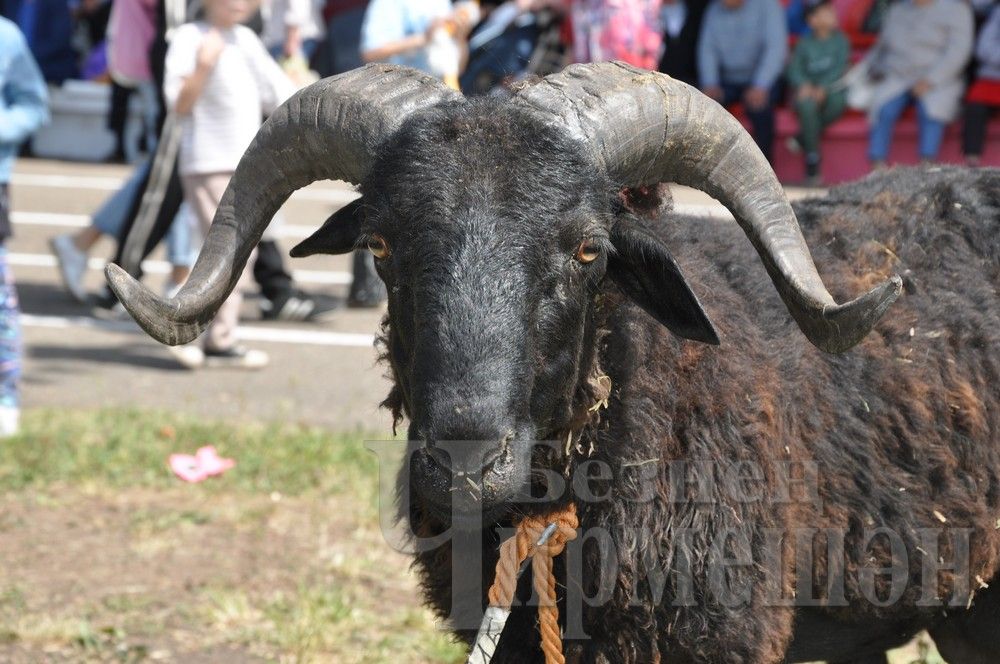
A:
[9, 160, 820, 431]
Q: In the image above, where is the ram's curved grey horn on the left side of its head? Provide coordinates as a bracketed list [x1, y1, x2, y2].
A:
[105, 64, 462, 345]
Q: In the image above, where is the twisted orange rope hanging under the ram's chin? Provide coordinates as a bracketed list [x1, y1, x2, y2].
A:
[489, 504, 579, 664]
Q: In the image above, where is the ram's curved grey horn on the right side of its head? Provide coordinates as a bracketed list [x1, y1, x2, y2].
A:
[516, 62, 902, 353]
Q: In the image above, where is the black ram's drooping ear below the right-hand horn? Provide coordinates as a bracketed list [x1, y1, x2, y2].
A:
[608, 222, 719, 345]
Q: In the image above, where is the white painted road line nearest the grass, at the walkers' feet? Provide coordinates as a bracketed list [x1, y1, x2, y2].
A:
[21, 314, 375, 348]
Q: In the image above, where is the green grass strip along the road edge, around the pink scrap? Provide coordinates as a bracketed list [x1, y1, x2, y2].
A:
[0, 410, 385, 496]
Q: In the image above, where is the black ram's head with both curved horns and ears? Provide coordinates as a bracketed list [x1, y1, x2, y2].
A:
[108, 63, 899, 528]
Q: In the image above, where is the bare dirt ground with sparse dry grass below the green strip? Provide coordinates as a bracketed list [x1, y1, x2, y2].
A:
[0, 487, 457, 664]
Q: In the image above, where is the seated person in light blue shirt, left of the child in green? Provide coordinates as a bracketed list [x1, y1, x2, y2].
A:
[698, 0, 788, 161]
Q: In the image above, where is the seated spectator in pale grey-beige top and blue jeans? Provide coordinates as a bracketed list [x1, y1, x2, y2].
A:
[865, 0, 973, 168]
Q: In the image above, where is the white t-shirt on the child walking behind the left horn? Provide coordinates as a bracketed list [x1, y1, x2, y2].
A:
[163, 22, 295, 175]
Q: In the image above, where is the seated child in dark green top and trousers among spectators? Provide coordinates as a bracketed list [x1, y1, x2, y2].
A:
[788, 0, 851, 186]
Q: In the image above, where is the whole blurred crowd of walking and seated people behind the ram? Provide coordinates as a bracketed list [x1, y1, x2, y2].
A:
[0, 0, 1000, 429]
